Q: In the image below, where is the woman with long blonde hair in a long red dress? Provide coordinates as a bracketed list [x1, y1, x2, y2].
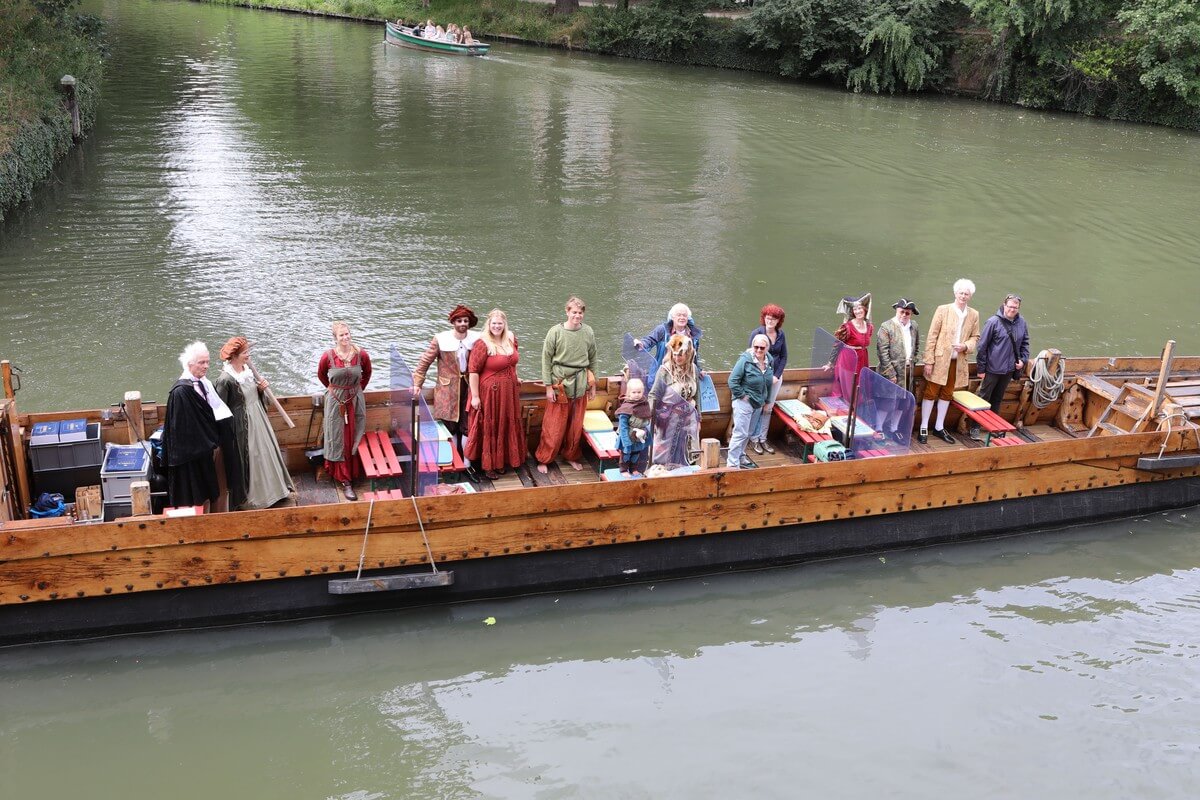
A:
[467, 308, 527, 479]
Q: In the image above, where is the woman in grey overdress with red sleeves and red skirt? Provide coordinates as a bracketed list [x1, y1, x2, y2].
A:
[317, 323, 371, 500]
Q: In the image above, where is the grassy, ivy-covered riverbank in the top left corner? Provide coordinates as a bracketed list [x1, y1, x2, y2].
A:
[0, 0, 103, 219]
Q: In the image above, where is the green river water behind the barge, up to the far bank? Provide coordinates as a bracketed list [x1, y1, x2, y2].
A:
[0, 0, 1200, 408]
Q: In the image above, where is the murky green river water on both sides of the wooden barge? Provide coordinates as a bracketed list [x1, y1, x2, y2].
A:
[0, 0, 1200, 800]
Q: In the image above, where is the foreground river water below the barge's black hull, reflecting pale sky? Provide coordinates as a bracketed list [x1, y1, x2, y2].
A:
[7, 515, 1200, 798]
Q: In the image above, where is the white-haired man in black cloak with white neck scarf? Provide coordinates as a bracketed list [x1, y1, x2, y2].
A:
[162, 342, 225, 511]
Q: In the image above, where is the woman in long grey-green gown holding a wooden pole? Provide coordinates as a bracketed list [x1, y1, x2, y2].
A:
[214, 336, 295, 510]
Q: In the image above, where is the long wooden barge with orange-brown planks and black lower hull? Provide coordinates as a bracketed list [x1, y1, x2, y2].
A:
[0, 348, 1200, 645]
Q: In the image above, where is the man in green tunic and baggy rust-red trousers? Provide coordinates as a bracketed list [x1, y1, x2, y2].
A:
[534, 297, 596, 474]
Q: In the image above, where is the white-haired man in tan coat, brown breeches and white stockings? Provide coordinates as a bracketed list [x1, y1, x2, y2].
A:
[917, 278, 979, 445]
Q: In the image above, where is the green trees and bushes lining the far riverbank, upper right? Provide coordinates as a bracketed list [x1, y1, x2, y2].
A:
[201, 0, 1200, 130]
